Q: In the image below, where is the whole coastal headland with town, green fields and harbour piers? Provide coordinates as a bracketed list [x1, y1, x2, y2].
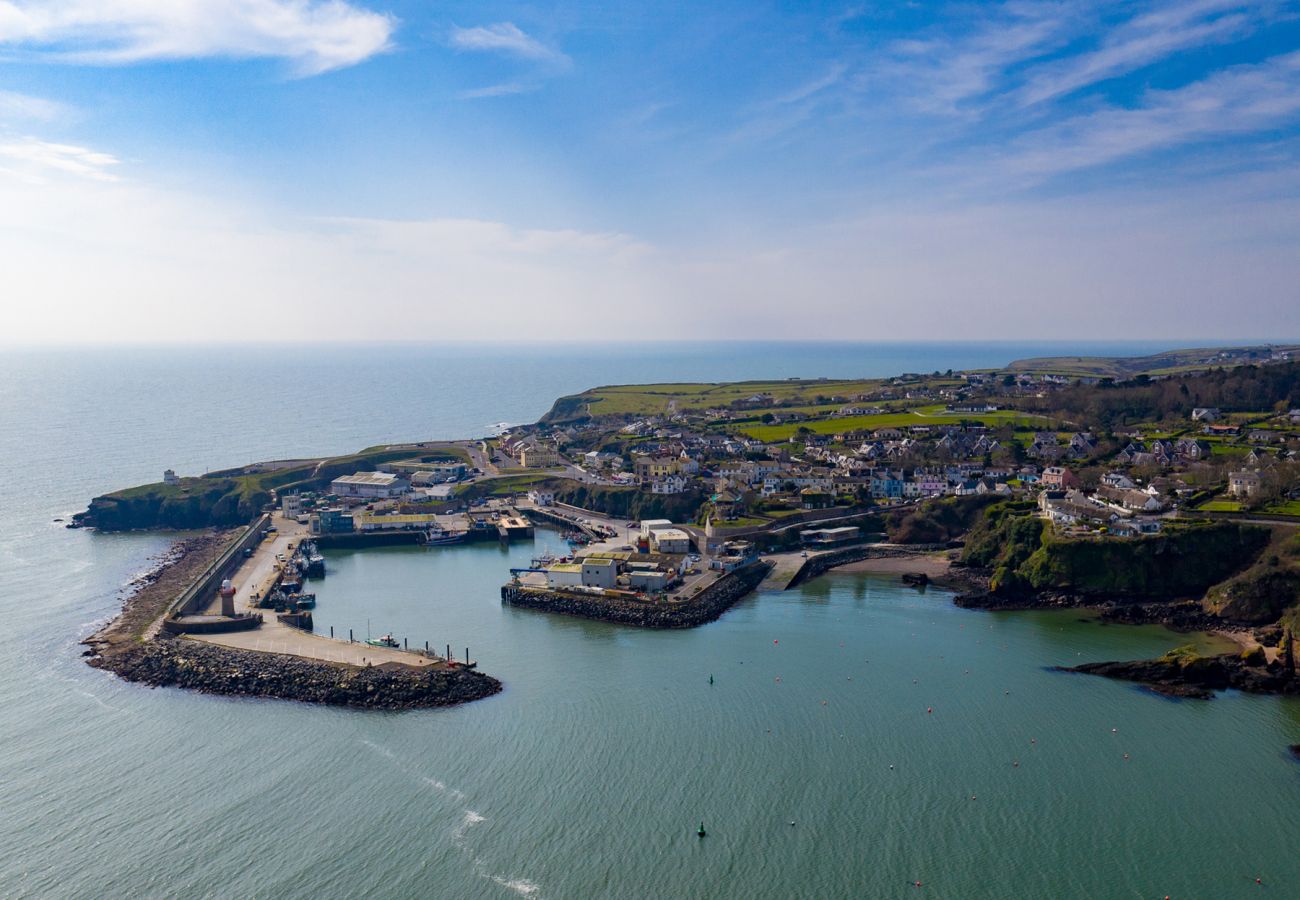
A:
[72, 345, 1300, 708]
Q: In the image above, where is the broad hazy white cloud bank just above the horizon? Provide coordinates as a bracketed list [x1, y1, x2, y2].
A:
[0, 150, 1300, 342]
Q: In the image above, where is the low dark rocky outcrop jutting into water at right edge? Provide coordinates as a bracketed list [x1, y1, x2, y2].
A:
[1058, 650, 1300, 700]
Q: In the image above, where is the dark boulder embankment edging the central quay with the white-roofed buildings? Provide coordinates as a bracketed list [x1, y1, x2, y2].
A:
[501, 562, 771, 628]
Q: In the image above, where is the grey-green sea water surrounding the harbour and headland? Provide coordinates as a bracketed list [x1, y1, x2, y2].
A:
[0, 345, 1300, 899]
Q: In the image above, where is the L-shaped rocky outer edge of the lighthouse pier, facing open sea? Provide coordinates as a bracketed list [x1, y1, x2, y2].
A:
[82, 531, 503, 710]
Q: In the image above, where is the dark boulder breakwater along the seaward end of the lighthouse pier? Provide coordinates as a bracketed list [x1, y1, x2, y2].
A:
[91, 637, 502, 709]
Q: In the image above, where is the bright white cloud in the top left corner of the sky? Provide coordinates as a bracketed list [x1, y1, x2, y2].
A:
[0, 0, 394, 75]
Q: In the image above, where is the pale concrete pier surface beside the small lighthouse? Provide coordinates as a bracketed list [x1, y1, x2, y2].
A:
[190, 514, 439, 666]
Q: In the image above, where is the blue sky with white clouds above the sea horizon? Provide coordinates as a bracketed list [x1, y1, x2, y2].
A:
[0, 0, 1300, 341]
